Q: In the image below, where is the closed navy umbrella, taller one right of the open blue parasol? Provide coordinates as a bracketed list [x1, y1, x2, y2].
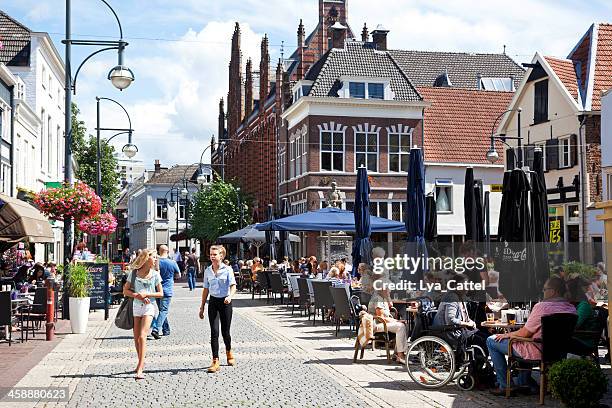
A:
[404, 148, 427, 282]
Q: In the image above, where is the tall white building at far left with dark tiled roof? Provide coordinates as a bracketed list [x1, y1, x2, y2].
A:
[0, 12, 65, 260]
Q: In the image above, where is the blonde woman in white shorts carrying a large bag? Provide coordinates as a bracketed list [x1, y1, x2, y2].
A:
[123, 249, 164, 380]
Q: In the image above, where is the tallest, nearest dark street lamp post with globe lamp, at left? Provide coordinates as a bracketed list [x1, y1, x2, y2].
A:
[62, 0, 134, 319]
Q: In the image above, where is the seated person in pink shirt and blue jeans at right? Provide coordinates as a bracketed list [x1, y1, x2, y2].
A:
[487, 276, 576, 395]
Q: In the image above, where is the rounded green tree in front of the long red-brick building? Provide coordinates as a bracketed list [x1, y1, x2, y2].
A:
[189, 179, 251, 242]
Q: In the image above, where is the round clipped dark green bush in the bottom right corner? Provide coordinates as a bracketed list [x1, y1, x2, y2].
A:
[548, 359, 608, 408]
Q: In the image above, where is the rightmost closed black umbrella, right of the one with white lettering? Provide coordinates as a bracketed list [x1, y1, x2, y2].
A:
[530, 149, 550, 297]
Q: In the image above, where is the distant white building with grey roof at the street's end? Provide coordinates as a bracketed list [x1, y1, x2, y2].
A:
[127, 160, 212, 255]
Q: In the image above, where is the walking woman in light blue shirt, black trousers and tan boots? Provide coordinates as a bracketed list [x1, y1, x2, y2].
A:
[200, 245, 236, 373]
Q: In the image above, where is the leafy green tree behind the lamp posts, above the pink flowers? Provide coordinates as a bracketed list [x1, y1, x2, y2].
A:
[72, 104, 120, 208]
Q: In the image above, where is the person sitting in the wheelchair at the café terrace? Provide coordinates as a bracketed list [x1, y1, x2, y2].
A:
[432, 274, 487, 354]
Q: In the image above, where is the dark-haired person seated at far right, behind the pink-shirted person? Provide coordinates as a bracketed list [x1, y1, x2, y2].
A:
[567, 276, 599, 355]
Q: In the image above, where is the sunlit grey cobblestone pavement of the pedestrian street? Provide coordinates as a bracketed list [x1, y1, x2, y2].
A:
[5, 284, 607, 408]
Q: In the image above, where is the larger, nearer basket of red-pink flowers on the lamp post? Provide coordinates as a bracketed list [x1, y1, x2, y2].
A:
[34, 181, 102, 221]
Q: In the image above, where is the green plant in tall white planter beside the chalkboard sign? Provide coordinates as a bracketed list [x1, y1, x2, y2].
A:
[68, 263, 93, 333]
